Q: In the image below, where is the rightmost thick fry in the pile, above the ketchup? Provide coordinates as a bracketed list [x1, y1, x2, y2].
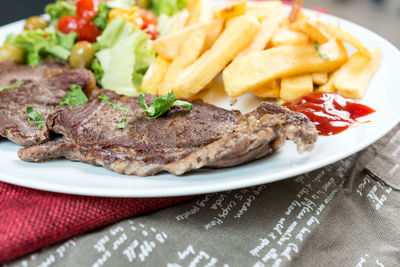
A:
[334, 48, 382, 99]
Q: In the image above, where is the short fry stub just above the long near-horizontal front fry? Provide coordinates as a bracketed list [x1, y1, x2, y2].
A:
[271, 27, 309, 47]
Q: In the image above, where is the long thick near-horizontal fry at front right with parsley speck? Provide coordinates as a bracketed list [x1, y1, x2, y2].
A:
[222, 40, 348, 97]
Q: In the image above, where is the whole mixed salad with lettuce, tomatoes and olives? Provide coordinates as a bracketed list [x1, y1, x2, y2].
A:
[0, 0, 188, 96]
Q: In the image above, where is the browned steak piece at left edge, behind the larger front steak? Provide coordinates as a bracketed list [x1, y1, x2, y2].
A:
[0, 61, 95, 145]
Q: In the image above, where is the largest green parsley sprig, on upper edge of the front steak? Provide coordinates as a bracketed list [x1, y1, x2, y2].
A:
[138, 91, 193, 119]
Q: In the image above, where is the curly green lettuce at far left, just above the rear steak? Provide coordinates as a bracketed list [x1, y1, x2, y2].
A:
[5, 29, 76, 66]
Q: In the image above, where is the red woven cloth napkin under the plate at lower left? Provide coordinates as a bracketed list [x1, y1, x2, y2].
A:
[0, 182, 194, 263]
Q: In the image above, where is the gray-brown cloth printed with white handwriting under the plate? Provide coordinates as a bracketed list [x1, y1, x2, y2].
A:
[9, 126, 400, 267]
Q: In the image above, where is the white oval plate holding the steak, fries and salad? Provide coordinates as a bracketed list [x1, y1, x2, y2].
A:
[0, 7, 400, 197]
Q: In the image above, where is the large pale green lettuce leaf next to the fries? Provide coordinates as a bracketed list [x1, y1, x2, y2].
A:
[95, 17, 155, 96]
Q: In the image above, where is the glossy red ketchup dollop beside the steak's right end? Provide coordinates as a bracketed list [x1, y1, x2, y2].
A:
[285, 92, 375, 135]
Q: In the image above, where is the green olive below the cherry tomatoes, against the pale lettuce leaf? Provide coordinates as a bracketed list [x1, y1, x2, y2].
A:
[69, 41, 95, 68]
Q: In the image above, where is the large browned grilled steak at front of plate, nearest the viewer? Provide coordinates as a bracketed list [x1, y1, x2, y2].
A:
[18, 91, 317, 176]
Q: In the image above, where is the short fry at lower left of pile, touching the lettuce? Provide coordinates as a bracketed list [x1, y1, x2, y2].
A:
[141, 56, 170, 95]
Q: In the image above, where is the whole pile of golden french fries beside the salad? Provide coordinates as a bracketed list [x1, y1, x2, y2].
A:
[142, 0, 382, 103]
